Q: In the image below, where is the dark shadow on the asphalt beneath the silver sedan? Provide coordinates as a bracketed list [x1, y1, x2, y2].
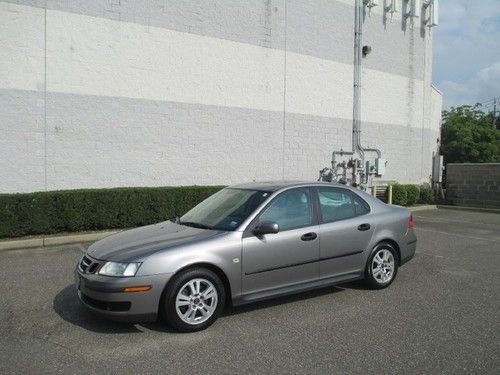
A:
[53, 281, 366, 334]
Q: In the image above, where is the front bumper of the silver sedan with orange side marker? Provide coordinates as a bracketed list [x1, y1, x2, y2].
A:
[75, 268, 172, 323]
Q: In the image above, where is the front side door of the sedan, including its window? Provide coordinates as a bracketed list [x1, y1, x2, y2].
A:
[242, 188, 319, 294]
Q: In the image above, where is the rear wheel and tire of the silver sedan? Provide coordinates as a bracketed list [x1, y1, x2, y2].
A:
[365, 242, 399, 289]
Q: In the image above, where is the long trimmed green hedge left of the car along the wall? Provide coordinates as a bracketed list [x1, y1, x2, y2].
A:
[0, 186, 223, 238]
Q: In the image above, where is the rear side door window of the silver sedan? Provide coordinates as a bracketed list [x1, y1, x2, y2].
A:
[318, 188, 369, 223]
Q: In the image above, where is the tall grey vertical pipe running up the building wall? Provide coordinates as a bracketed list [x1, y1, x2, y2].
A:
[352, 0, 382, 165]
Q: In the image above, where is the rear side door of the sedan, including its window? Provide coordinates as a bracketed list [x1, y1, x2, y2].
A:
[316, 187, 375, 278]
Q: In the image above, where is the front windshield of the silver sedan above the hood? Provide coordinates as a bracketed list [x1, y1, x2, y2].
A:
[179, 188, 271, 231]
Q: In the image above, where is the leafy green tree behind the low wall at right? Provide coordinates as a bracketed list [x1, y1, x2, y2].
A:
[441, 104, 500, 163]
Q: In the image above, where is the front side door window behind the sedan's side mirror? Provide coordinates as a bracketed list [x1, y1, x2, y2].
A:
[259, 188, 313, 232]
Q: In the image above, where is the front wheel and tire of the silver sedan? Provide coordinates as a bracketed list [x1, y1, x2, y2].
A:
[160, 268, 226, 332]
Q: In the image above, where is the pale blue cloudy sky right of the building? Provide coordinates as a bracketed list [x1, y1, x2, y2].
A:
[433, 0, 500, 110]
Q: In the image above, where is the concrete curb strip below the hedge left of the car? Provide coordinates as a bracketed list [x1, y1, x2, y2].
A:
[0, 230, 120, 251]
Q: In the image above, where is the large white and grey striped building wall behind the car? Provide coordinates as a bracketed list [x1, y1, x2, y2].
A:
[0, 0, 441, 192]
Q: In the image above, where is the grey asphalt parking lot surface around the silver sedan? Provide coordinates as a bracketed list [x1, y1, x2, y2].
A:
[0, 209, 500, 374]
